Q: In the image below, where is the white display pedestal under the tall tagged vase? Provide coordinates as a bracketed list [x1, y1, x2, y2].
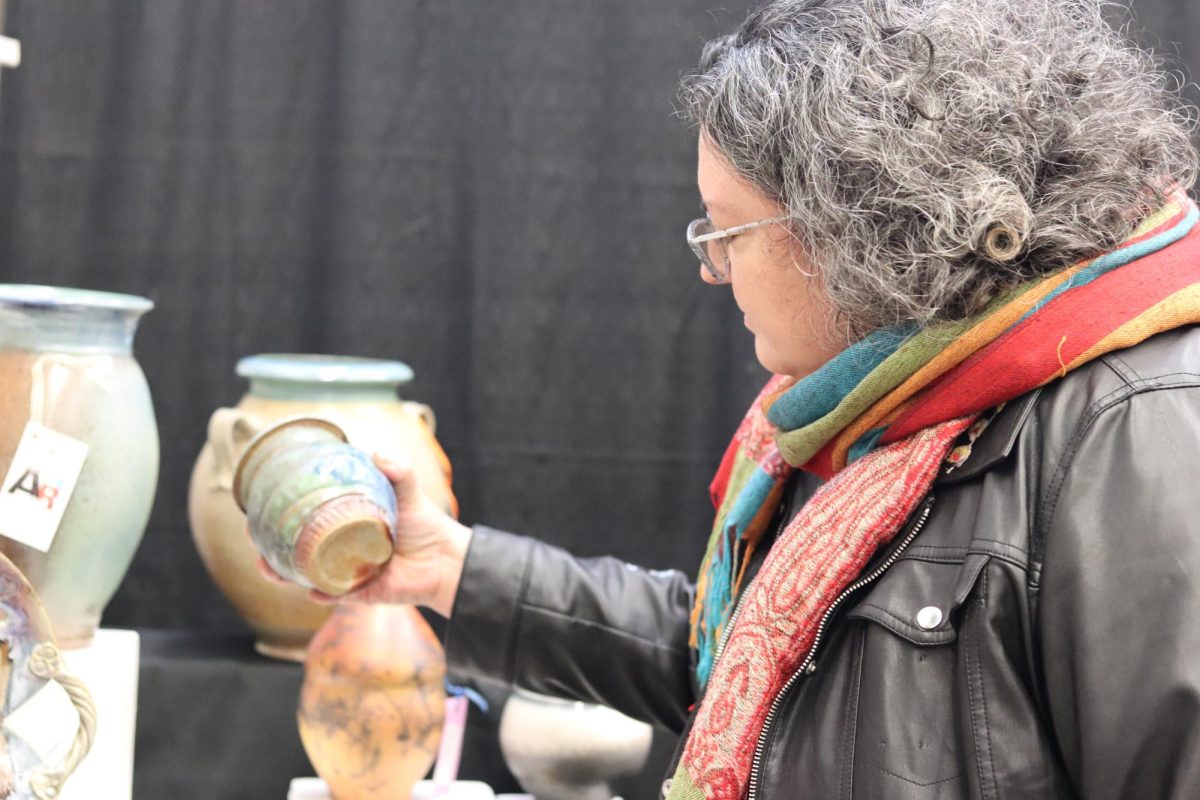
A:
[4, 630, 139, 800]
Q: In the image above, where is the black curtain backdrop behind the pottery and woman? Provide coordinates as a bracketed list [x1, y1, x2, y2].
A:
[0, 0, 1200, 652]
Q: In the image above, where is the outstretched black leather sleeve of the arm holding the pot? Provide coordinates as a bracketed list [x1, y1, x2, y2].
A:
[445, 527, 694, 732]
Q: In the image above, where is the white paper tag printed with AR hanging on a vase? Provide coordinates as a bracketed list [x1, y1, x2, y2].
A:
[0, 422, 88, 553]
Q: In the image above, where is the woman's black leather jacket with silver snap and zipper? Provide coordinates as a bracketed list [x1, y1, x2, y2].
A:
[446, 327, 1200, 799]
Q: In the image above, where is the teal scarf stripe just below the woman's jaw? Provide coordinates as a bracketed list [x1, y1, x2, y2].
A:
[767, 323, 918, 431]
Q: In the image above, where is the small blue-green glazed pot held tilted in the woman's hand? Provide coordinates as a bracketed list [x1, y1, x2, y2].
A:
[233, 416, 396, 595]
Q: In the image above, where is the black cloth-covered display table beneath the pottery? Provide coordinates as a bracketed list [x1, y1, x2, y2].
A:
[132, 630, 674, 800]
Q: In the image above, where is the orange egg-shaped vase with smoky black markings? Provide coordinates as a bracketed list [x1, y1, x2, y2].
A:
[298, 604, 445, 800]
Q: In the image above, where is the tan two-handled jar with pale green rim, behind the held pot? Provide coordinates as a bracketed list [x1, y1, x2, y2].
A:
[187, 354, 455, 661]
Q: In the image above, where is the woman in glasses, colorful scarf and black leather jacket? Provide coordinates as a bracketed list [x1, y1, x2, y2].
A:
[272, 0, 1200, 800]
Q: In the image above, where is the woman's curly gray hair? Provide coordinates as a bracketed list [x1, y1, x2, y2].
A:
[680, 0, 1198, 336]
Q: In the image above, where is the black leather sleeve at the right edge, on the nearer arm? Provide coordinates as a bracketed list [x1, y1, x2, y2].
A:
[1034, 377, 1200, 798]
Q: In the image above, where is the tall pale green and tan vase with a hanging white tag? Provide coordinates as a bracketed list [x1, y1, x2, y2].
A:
[0, 285, 158, 648]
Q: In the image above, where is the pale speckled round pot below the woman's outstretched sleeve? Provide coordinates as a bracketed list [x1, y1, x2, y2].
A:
[500, 688, 653, 800]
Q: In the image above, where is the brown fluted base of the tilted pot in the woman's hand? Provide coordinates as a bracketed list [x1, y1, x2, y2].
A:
[295, 495, 392, 596]
